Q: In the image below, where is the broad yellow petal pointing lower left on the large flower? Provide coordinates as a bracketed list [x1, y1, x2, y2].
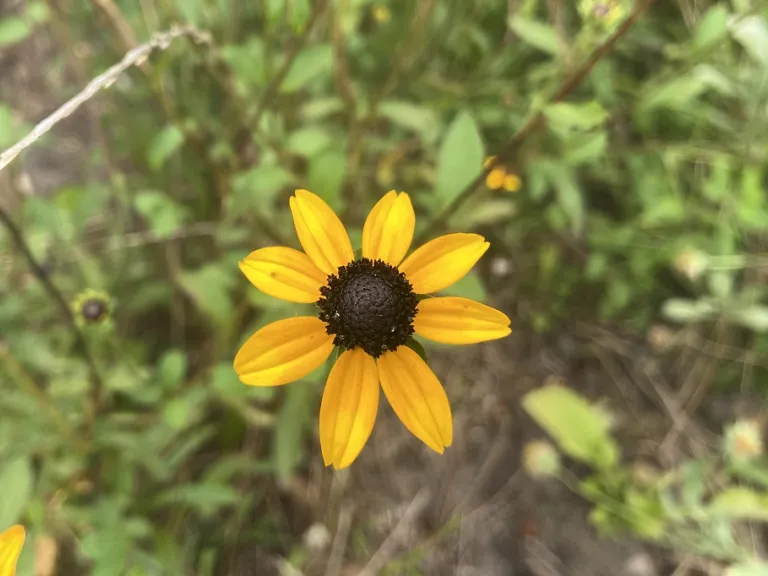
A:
[235, 316, 333, 386]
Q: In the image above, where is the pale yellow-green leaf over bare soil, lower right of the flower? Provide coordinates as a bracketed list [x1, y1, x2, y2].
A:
[523, 384, 619, 469]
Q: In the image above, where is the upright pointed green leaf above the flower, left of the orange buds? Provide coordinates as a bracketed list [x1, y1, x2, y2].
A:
[435, 112, 485, 205]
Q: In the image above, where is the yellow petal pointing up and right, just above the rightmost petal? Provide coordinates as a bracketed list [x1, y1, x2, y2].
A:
[399, 234, 490, 294]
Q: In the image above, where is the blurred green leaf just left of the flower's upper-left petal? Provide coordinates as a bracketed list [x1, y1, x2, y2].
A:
[178, 264, 234, 324]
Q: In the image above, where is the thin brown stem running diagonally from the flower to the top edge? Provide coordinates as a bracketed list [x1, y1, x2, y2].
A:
[416, 0, 655, 242]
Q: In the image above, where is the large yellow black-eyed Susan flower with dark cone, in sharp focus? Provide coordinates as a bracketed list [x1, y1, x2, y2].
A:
[234, 190, 510, 469]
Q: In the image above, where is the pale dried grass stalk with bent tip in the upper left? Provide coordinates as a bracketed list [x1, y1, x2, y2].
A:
[0, 26, 210, 171]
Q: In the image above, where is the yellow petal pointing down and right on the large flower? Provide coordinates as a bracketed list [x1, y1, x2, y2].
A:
[377, 346, 453, 454]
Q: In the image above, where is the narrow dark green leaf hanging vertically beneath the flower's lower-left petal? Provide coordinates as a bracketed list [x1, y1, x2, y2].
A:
[273, 383, 312, 480]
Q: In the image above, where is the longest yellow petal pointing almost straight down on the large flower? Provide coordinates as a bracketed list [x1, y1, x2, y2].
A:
[320, 348, 379, 470]
